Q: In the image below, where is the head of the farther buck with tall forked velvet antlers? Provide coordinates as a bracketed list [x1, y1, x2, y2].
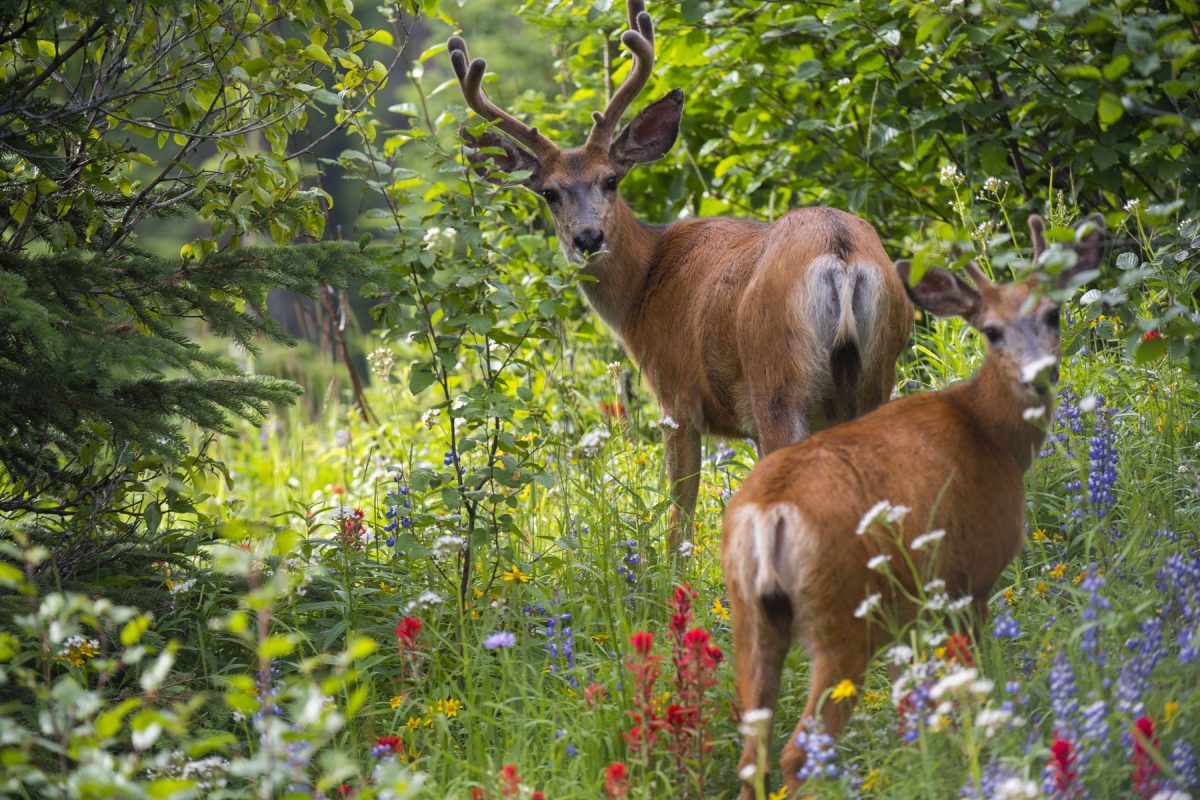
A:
[446, 0, 683, 261]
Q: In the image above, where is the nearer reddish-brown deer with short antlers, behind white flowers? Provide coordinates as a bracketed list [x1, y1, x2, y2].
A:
[721, 215, 1104, 800]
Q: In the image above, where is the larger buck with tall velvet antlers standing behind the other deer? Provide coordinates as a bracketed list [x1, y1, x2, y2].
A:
[448, 0, 912, 551]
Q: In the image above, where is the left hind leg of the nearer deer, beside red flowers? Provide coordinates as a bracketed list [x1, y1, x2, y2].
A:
[730, 583, 793, 800]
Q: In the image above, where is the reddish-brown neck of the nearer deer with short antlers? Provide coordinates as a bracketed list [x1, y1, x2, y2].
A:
[962, 354, 1054, 473]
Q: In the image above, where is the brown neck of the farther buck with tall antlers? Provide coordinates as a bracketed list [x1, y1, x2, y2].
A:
[581, 196, 666, 339]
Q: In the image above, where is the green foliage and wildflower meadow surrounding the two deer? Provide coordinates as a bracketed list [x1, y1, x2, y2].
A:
[0, 0, 1200, 800]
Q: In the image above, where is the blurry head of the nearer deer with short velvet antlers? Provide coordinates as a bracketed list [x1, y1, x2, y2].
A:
[896, 215, 1104, 405]
